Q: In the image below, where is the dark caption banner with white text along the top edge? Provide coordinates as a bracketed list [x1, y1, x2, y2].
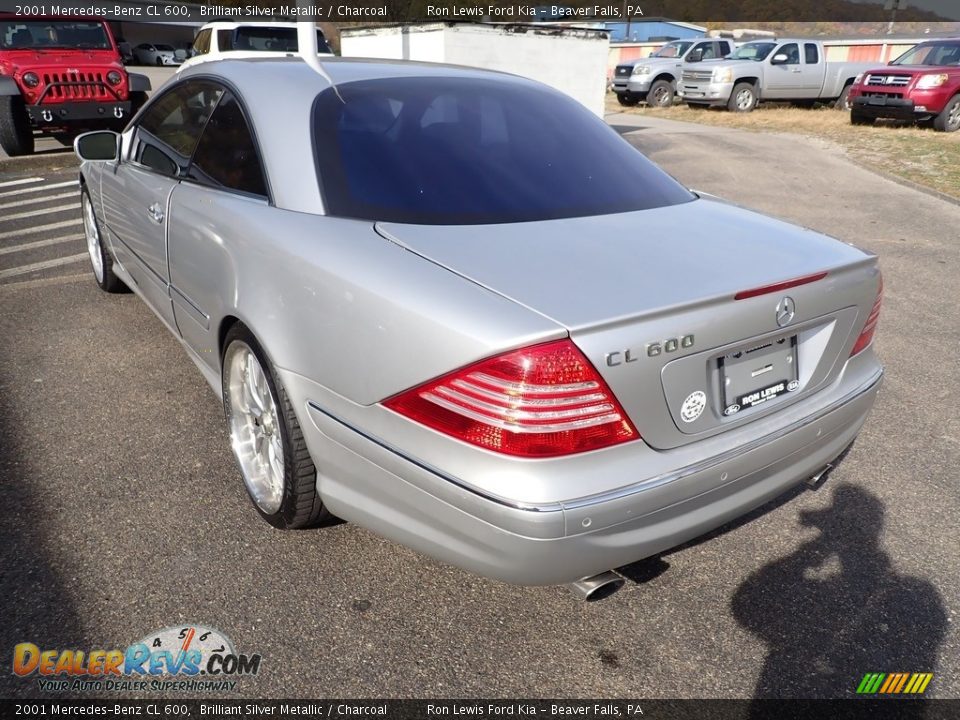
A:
[0, 0, 960, 23]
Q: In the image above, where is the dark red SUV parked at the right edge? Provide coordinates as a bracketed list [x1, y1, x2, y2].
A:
[850, 38, 960, 132]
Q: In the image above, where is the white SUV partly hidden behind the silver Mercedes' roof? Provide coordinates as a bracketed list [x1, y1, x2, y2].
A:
[181, 22, 333, 69]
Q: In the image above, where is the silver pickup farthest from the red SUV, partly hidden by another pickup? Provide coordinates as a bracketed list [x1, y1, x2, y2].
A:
[612, 39, 733, 107]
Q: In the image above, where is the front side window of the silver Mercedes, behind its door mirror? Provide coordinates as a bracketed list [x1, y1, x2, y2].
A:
[133, 81, 223, 176]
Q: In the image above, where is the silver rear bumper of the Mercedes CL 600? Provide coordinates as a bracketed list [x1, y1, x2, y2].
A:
[284, 367, 882, 585]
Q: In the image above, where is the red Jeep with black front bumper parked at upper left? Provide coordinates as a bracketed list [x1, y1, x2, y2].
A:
[0, 13, 150, 156]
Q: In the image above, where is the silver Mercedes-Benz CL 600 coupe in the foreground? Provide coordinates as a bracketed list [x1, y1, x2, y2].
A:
[75, 58, 882, 593]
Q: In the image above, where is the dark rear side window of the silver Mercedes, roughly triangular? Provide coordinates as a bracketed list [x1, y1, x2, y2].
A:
[188, 93, 267, 197]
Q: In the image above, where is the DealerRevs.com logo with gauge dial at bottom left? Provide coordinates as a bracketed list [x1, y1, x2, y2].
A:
[13, 625, 261, 692]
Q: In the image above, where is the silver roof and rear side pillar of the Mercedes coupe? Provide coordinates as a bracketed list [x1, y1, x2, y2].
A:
[177, 57, 544, 213]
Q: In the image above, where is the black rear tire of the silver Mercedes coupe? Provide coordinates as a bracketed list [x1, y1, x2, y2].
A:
[221, 323, 334, 530]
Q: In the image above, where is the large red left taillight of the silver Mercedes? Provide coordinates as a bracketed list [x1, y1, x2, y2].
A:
[384, 340, 640, 458]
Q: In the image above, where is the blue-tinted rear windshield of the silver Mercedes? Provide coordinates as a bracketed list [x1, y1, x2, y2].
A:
[314, 77, 693, 225]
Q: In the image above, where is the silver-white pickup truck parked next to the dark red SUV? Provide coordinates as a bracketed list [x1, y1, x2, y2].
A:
[677, 39, 876, 112]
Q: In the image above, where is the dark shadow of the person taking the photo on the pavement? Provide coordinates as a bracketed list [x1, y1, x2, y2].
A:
[731, 483, 947, 704]
